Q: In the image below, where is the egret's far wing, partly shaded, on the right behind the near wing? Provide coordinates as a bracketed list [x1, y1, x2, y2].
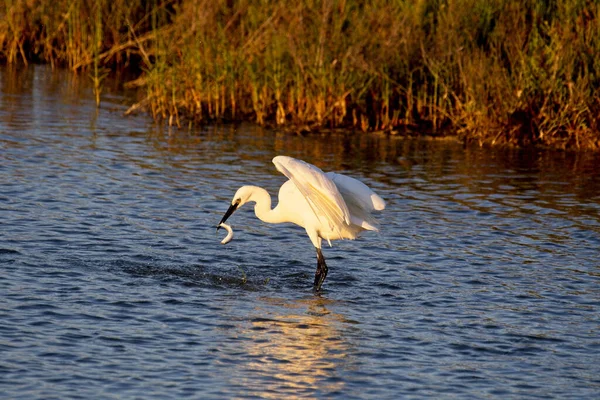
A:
[325, 172, 385, 231]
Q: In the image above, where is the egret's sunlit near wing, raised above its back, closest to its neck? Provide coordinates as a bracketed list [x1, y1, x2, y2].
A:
[273, 156, 350, 232]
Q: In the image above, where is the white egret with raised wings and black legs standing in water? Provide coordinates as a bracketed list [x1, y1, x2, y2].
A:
[217, 156, 385, 291]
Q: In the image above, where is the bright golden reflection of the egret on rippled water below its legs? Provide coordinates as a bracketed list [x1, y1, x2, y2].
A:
[231, 297, 353, 398]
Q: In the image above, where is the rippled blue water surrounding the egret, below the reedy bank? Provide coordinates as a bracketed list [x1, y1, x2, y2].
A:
[0, 66, 600, 399]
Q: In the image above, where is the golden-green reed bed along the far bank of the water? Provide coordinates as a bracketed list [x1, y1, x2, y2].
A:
[0, 0, 600, 150]
